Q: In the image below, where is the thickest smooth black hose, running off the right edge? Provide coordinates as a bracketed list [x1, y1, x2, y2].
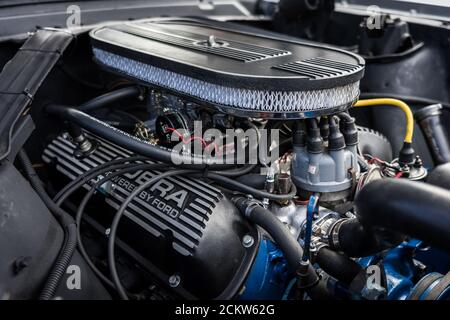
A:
[355, 179, 450, 251]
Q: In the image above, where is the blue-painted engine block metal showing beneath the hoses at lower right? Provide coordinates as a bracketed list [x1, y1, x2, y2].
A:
[239, 238, 450, 300]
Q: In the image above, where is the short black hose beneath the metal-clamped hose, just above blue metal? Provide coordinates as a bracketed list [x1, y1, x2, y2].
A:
[315, 247, 362, 285]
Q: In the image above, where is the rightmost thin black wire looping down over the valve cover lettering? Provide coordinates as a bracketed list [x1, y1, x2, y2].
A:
[108, 170, 195, 300]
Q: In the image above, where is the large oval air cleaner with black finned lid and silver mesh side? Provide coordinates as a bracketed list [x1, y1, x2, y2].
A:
[91, 19, 364, 119]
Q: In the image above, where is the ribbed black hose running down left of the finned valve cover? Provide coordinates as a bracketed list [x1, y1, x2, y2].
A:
[18, 150, 77, 300]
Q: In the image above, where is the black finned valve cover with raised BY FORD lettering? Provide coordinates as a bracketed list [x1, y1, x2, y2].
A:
[43, 135, 258, 299]
